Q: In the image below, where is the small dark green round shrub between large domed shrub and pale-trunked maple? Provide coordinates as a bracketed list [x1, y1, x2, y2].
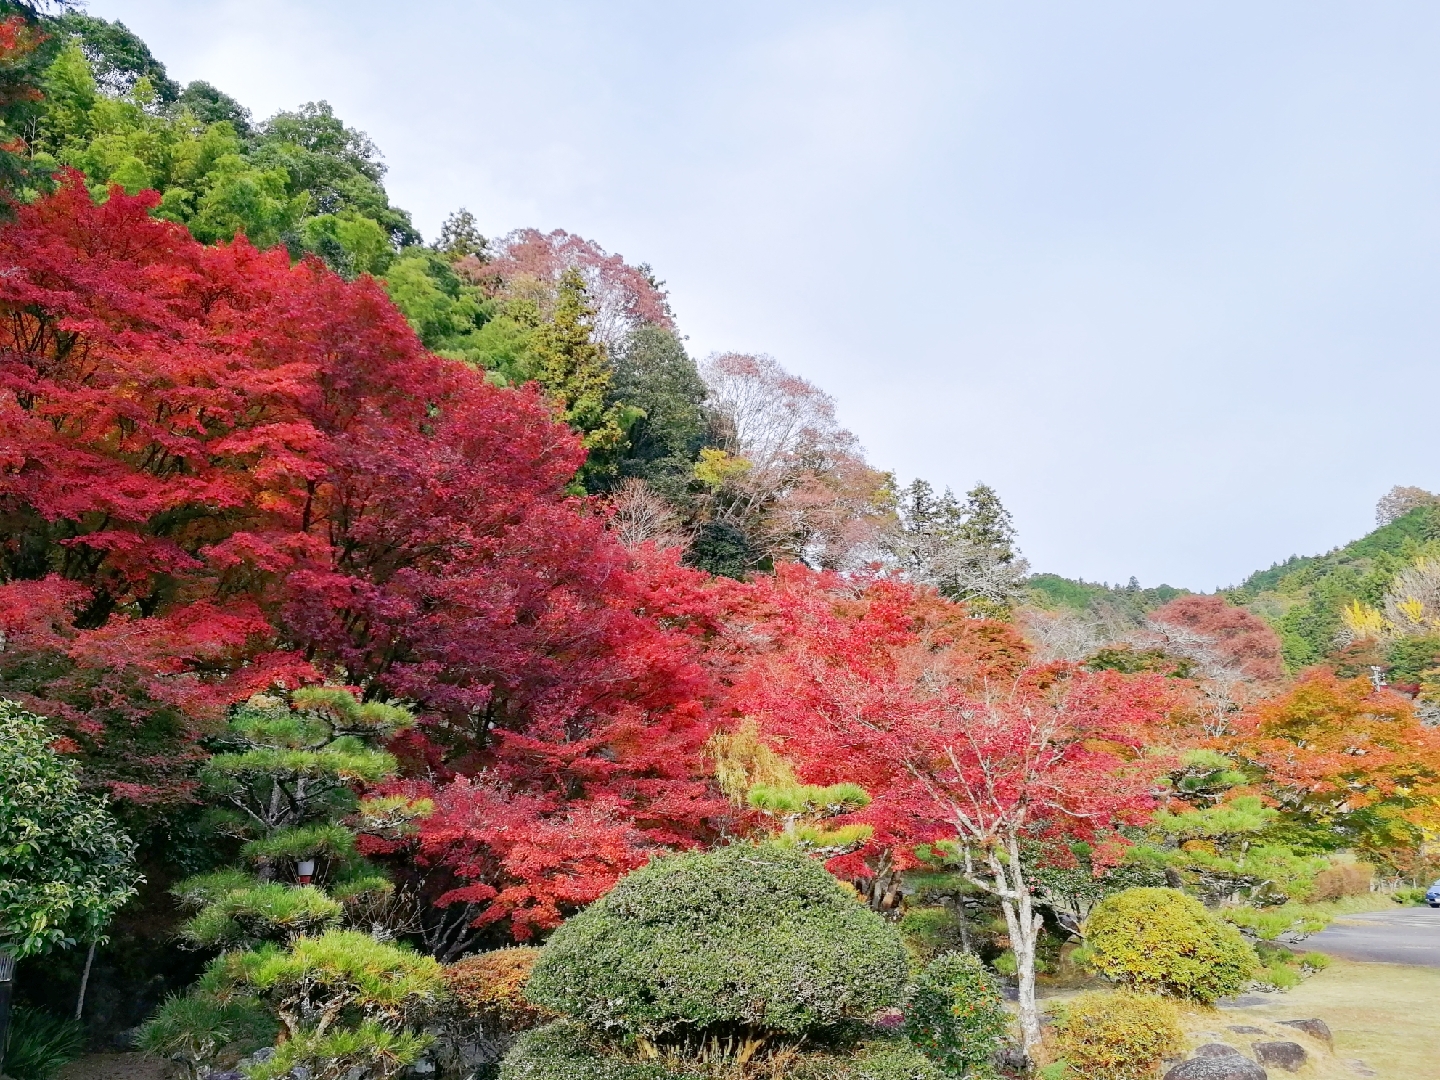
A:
[904, 952, 1009, 1077]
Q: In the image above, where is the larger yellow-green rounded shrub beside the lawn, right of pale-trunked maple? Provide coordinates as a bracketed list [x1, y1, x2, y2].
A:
[1084, 888, 1260, 1005]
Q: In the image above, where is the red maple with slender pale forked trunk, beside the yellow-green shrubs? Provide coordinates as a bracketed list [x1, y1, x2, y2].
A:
[720, 572, 1178, 1048]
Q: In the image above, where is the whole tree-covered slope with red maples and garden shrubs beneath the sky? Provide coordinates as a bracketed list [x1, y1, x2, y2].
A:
[0, 4, 1440, 1080]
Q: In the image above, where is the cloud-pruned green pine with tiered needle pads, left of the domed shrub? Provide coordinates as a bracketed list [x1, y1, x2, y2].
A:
[140, 687, 441, 1077]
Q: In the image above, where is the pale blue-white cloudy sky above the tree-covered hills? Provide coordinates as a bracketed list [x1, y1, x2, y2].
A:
[88, 0, 1440, 589]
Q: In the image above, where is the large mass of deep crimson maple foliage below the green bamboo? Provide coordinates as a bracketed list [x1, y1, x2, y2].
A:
[0, 176, 720, 869]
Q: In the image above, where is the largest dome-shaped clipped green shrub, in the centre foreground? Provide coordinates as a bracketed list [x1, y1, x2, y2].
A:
[526, 844, 906, 1038]
